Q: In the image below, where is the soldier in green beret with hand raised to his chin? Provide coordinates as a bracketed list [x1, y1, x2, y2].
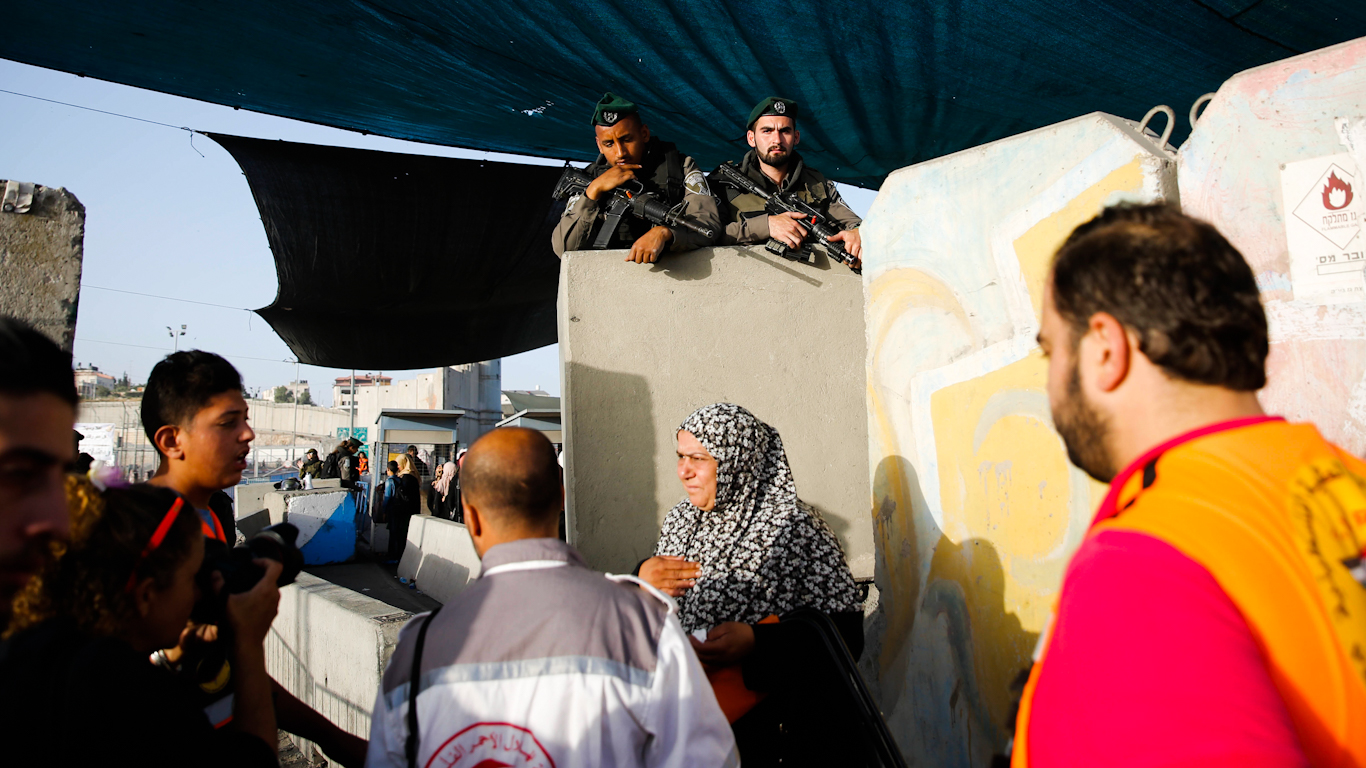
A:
[550, 93, 720, 264]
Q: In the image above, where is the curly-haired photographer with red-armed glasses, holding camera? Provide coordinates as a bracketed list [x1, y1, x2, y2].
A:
[0, 476, 280, 768]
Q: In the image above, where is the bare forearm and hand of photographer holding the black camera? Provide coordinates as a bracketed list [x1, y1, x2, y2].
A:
[228, 559, 284, 750]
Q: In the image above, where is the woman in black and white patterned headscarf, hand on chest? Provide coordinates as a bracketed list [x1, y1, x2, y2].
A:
[638, 403, 863, 765]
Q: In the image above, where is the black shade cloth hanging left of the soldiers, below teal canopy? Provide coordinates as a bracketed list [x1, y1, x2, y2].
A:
[210, 134, 560, 370]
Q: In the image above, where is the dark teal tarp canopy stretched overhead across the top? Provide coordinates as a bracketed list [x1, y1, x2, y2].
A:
[10, 0, 1366, 187]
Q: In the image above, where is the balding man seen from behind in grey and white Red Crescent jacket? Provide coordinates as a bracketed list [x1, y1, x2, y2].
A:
[367, 428, 738, 768]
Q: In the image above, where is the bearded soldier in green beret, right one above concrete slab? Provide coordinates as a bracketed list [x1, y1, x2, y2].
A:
[717, 96, 863, 265]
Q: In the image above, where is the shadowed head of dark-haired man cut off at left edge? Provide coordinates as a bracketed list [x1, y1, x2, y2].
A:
[0, 317, 76, 627]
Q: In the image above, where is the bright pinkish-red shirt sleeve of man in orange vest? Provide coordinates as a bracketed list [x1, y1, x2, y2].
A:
[1029, 530, 1309, 768]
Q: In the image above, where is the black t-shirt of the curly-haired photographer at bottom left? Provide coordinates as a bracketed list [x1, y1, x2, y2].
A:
[0, 618, 279, 768]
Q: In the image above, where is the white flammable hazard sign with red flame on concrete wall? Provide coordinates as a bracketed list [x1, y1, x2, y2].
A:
[1281, 153, 1366, 303]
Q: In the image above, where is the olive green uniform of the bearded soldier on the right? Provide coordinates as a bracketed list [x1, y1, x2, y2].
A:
[714, 149, 863, 245]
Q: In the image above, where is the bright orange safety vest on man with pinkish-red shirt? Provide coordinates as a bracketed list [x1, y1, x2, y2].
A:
[1011, 417, 1366, 768]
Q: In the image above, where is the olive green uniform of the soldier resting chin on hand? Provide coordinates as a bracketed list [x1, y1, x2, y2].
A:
[550, 138, 721, 258]
